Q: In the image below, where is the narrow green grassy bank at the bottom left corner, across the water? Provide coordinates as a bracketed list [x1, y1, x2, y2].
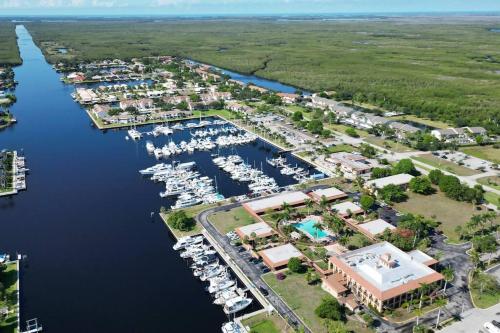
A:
[0, 263, 19, 333]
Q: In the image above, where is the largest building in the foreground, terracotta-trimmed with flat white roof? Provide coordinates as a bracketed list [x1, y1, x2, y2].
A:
[325, 242, 443, 312]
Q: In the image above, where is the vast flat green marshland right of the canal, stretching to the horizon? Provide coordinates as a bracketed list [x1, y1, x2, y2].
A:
[26, 16, 500, 132]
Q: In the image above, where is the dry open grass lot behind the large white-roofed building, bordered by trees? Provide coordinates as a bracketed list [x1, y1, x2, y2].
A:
[394, 191, 496, 242]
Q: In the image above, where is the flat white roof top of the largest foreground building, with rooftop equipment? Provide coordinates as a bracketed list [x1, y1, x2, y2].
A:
[339, 242, 434, 291]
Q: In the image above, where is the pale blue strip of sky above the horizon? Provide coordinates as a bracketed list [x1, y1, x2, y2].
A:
[0, 0, 500, 15]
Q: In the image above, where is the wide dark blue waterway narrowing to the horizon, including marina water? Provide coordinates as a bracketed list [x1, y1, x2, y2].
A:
[0, 26, 314, 333]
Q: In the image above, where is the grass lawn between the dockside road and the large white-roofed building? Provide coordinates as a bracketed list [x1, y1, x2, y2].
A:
[262, 273, 373, 333]
